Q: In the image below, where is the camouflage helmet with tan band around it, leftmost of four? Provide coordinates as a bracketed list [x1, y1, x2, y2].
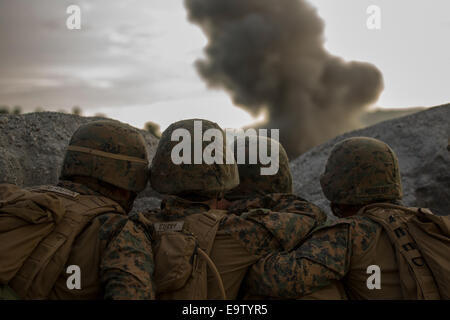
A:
[61, 120, 148, 193]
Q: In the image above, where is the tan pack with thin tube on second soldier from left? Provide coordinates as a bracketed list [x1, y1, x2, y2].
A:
[148, 210, 226, 300]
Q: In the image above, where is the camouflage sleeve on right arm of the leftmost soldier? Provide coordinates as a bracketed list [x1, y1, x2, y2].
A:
[100, 216, 155, 300]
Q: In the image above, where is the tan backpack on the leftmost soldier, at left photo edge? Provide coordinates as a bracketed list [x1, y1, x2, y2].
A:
[0, 185, 125, 299]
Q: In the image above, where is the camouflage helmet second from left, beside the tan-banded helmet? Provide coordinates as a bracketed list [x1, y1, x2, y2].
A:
[150, 119, 239, 197]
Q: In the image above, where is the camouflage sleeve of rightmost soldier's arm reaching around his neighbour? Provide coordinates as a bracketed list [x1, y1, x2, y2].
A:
[246, 224, 352, 299]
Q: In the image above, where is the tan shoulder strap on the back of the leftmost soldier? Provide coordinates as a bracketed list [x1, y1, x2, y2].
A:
[9, 187, 124, 299]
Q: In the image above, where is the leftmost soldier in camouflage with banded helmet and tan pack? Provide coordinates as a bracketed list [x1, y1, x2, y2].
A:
[0, 121, 154, 300]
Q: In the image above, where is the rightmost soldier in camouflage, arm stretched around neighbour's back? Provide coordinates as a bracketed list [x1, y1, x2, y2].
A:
[244, 137, 417, 299]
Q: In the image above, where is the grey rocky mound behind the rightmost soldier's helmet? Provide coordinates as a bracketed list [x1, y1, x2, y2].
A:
[291, 104, 450, 215]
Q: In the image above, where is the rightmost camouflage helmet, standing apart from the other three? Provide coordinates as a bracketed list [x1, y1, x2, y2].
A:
[320, 137, 402, 205]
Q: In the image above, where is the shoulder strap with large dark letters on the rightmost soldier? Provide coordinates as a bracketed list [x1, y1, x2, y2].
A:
[358, 203, 440, 300]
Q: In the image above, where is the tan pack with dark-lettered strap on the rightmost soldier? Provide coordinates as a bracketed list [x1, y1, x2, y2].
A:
[358, 203, 450, 300]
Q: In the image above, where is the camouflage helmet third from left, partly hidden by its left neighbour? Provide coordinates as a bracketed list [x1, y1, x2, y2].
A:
[227, 136, 292, 199]
